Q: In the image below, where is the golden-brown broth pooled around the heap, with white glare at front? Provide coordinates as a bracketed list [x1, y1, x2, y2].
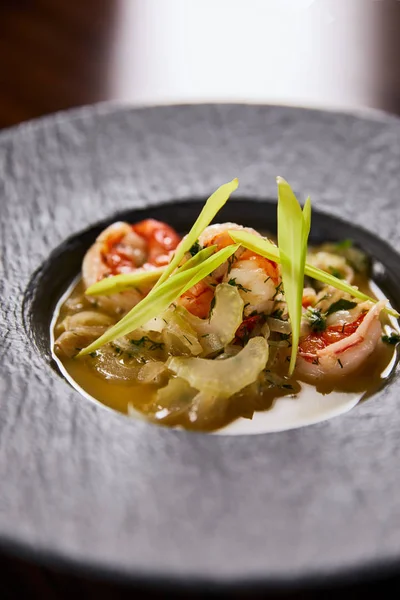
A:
[52, 280, 394, 434]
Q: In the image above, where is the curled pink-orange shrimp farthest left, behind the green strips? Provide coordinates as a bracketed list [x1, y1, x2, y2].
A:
[82, 219, 181, 312]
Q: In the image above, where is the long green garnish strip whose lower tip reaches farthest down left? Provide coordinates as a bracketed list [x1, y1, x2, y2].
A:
[77, 244, 238, 357]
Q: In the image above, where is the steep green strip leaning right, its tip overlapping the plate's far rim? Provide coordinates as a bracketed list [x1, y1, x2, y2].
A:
[153, 179, 239, 289]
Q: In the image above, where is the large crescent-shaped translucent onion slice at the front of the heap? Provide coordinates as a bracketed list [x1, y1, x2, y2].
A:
[167, 337, 268, 398]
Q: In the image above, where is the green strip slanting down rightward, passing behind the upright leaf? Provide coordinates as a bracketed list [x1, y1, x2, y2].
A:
[229, 230, 400, 318]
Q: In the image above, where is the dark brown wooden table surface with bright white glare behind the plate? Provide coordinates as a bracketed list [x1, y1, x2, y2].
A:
[0, 0, 400, 599]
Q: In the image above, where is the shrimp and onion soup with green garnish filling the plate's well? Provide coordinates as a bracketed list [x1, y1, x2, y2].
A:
[53, 177, 398, 433]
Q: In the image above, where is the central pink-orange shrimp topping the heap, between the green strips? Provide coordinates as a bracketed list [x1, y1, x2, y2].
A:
[179, 223, 281, 319]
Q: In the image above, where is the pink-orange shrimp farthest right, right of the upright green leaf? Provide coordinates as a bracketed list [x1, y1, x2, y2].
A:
[296, 300, 386, 380]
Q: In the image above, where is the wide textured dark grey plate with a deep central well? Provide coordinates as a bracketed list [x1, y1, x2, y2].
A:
[0, 105, 400, 588]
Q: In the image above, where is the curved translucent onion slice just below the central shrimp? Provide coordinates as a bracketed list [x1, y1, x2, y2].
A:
[177, 283, 244, 356]
